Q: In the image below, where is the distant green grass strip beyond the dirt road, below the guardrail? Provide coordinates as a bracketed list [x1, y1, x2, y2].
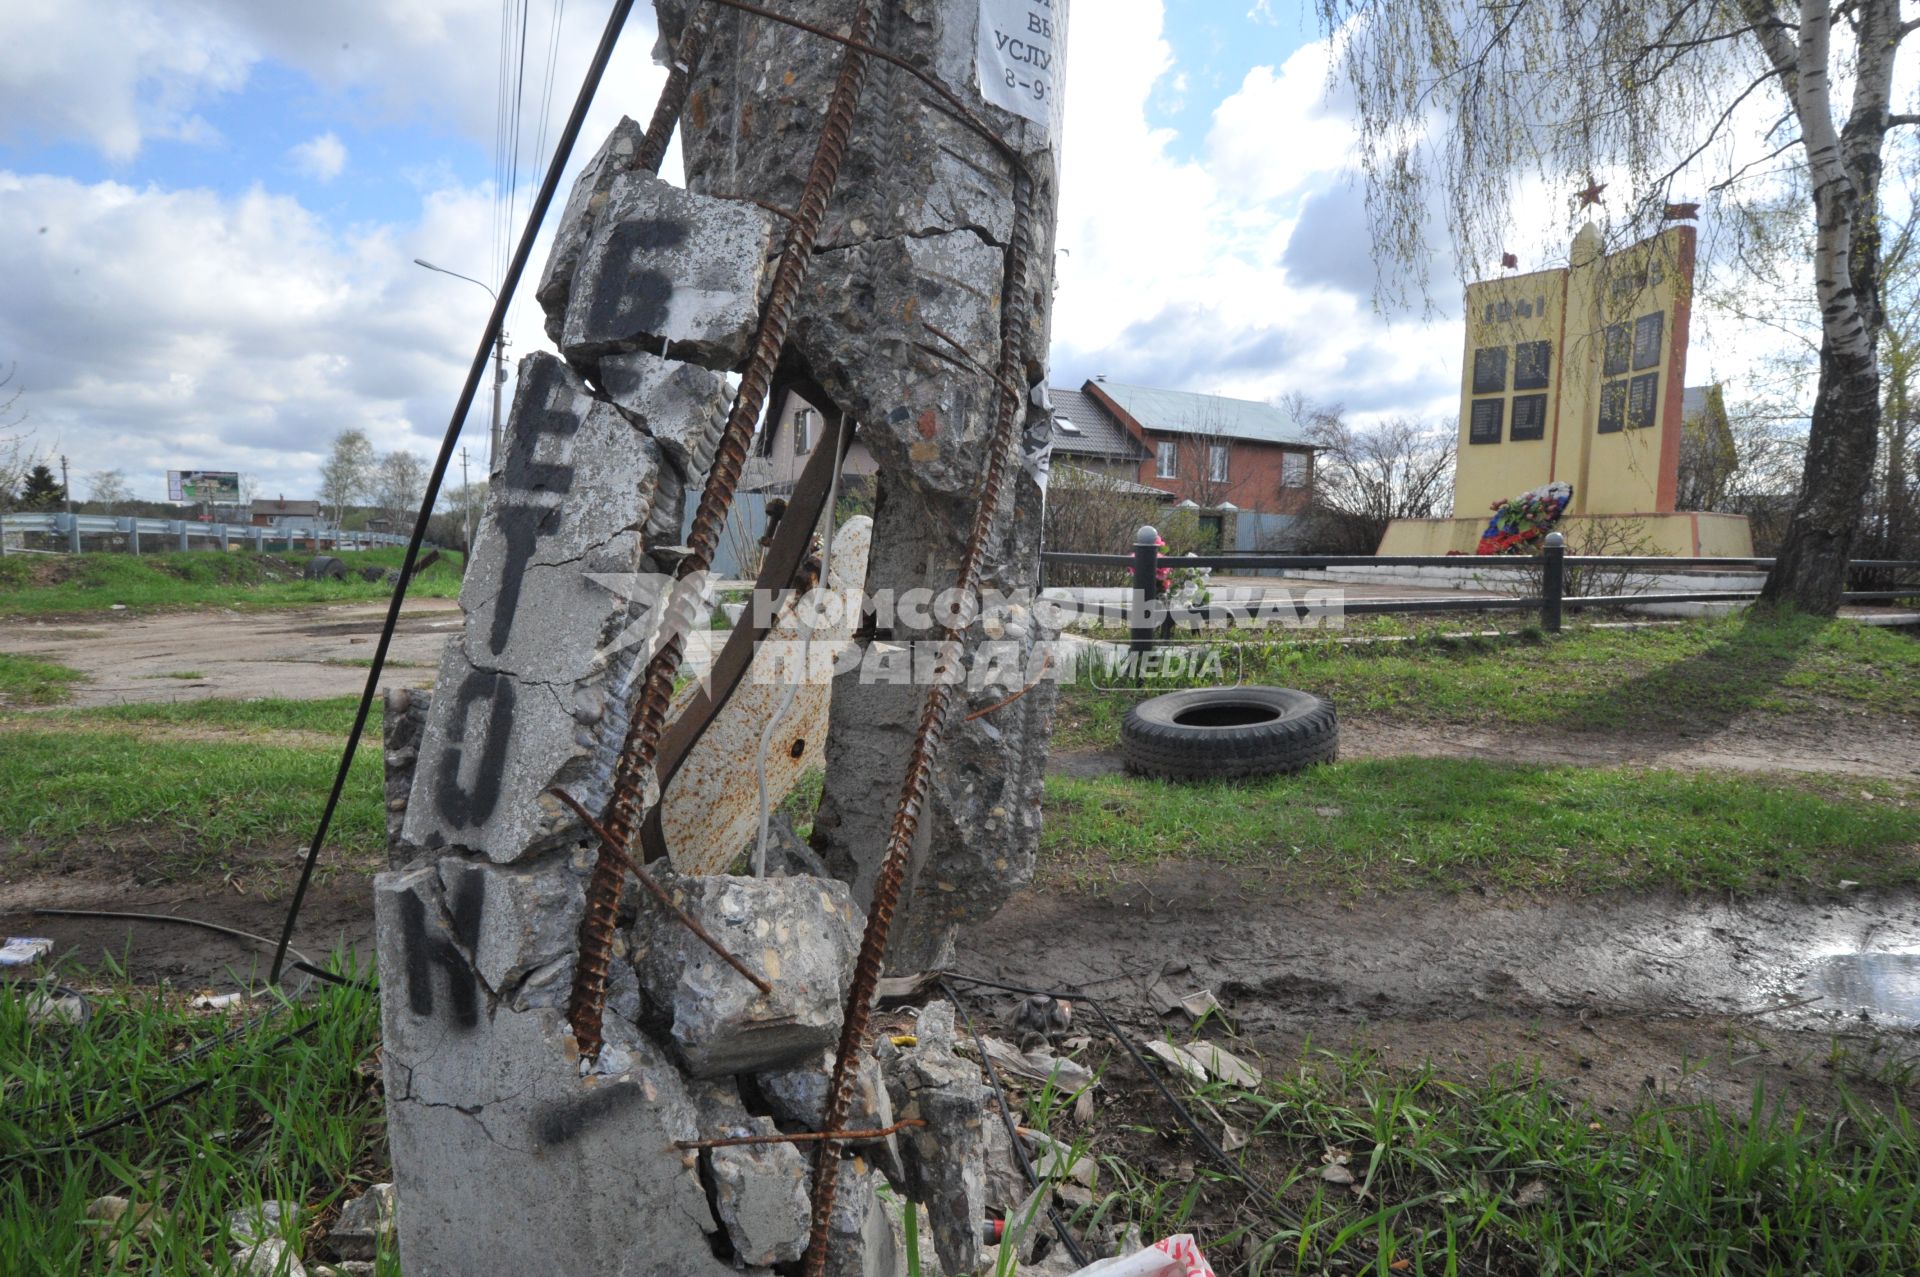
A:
[0, 549, 461, 616]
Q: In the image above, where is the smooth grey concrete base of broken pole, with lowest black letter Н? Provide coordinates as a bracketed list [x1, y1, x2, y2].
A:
[374, 866, 745, 1277]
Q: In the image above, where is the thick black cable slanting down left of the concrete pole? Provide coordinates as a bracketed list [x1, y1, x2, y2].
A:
[267, 0, 634, 983]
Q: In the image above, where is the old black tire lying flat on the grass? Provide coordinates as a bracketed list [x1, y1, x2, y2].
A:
[1119, 687, 1340, 780]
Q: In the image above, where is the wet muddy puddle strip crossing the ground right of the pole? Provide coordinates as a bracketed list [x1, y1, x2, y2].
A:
[962, 870, 1920, 1029]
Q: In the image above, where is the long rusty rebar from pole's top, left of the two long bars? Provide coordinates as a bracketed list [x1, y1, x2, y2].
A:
[566, 0, 872, 1060]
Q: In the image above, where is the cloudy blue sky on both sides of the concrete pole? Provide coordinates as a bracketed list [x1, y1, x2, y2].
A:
[0, 0, 1620, 499]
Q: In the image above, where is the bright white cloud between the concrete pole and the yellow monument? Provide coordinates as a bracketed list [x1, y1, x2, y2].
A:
[1054, 0, 1459, 417]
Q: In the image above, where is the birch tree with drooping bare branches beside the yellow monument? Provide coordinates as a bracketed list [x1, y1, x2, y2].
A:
[1317, 0, 1920, 614]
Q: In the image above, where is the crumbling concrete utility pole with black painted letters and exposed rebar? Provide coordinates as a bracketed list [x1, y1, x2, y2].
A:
[372, 0, 1064, 1277]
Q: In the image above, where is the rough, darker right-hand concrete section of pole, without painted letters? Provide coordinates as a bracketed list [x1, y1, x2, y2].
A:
[657, 0, 1066, 970]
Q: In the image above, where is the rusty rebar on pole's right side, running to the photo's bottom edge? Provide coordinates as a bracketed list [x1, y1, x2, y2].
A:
[803, 171, 1033, 1277]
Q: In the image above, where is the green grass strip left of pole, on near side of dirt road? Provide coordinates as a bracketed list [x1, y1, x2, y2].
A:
[0, 697, 386, 876]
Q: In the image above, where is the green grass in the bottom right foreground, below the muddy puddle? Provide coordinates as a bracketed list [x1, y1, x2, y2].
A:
[1029, 1045, 1920, 1277]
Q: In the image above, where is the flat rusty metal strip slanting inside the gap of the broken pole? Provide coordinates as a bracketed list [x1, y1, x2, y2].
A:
[639, 405, 852, 862]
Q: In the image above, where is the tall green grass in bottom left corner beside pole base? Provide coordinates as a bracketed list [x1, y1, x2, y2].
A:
[0, 960, 399, 1277]
